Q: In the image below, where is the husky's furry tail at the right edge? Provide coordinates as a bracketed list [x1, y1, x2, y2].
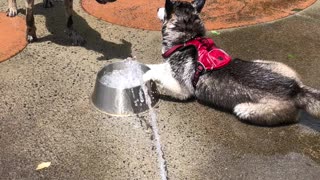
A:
[296, 86, 320, 119]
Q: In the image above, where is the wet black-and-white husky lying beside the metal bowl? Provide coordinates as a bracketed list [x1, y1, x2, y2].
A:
[143, 0, 320, 126]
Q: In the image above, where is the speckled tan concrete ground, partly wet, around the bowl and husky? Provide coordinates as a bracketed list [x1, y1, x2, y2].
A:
[0, 0, 320, 180]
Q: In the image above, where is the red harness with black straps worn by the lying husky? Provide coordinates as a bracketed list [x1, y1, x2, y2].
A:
[162, 38, 231, 87]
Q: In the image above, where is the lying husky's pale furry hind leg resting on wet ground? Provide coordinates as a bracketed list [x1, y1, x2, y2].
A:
[233, 99, 298, 125]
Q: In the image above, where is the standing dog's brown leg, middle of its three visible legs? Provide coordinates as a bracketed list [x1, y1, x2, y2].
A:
[26, 0, 37, 42]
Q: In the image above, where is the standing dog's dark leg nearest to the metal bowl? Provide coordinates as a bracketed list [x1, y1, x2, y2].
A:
[64, 0, 85, 46]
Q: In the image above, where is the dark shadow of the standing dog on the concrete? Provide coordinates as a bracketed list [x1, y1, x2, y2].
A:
[24, 2, 132, 60]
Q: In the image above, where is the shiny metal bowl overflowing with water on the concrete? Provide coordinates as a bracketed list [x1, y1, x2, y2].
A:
[92, 61, 159, 116]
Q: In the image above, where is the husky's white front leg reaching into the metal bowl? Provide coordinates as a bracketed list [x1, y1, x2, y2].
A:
[143, 63, 191, 100]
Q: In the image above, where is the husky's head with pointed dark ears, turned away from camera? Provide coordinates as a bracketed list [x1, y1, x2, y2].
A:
[158, 0, 205, 46]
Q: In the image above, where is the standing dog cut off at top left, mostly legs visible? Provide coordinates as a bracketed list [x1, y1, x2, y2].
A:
[7, 0, 114, 45]
